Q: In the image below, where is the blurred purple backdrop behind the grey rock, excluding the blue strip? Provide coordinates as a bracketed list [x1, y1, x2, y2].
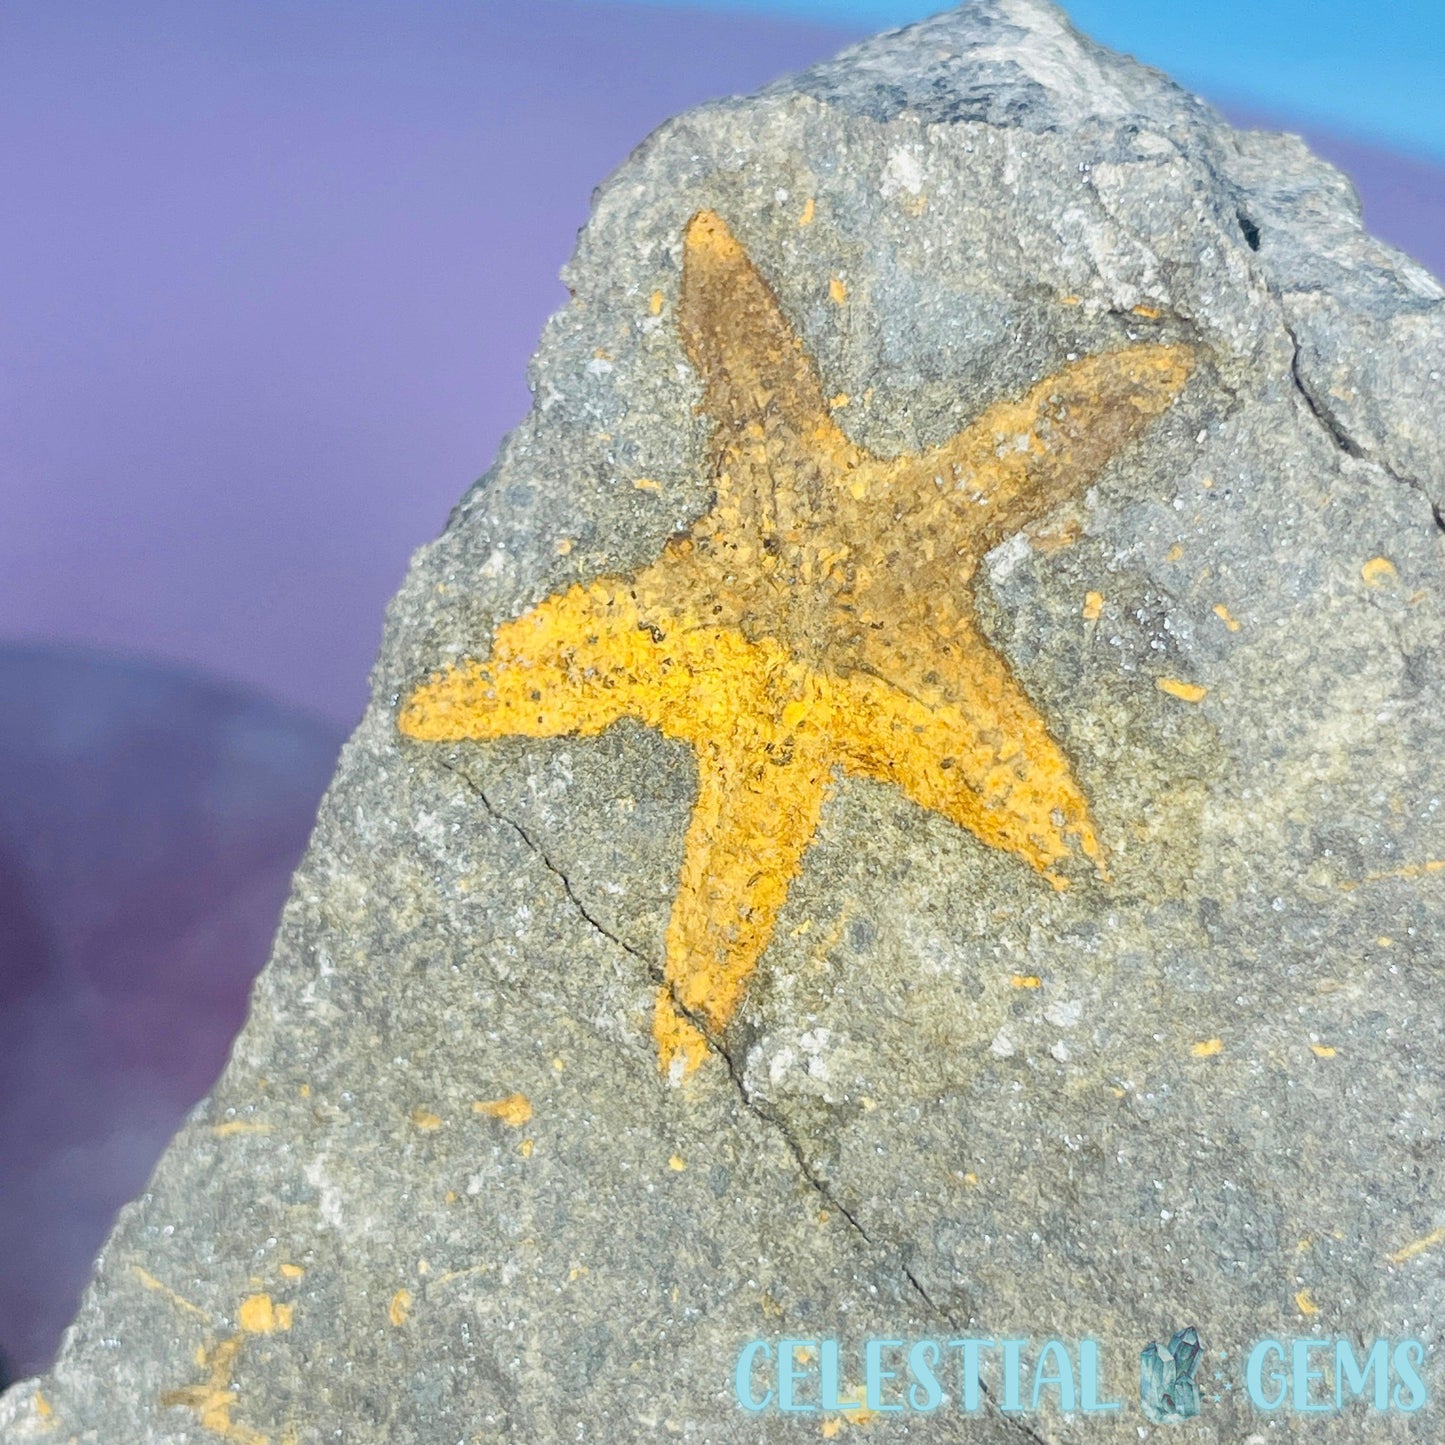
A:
[0, 0, 1445, 1373]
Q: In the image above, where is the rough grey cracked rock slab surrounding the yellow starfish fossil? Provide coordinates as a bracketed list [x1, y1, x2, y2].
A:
[0, 0, 1445, 1445]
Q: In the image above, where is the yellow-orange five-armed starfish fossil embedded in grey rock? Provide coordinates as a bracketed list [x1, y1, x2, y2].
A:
[399, 211, 1192, 1078]
